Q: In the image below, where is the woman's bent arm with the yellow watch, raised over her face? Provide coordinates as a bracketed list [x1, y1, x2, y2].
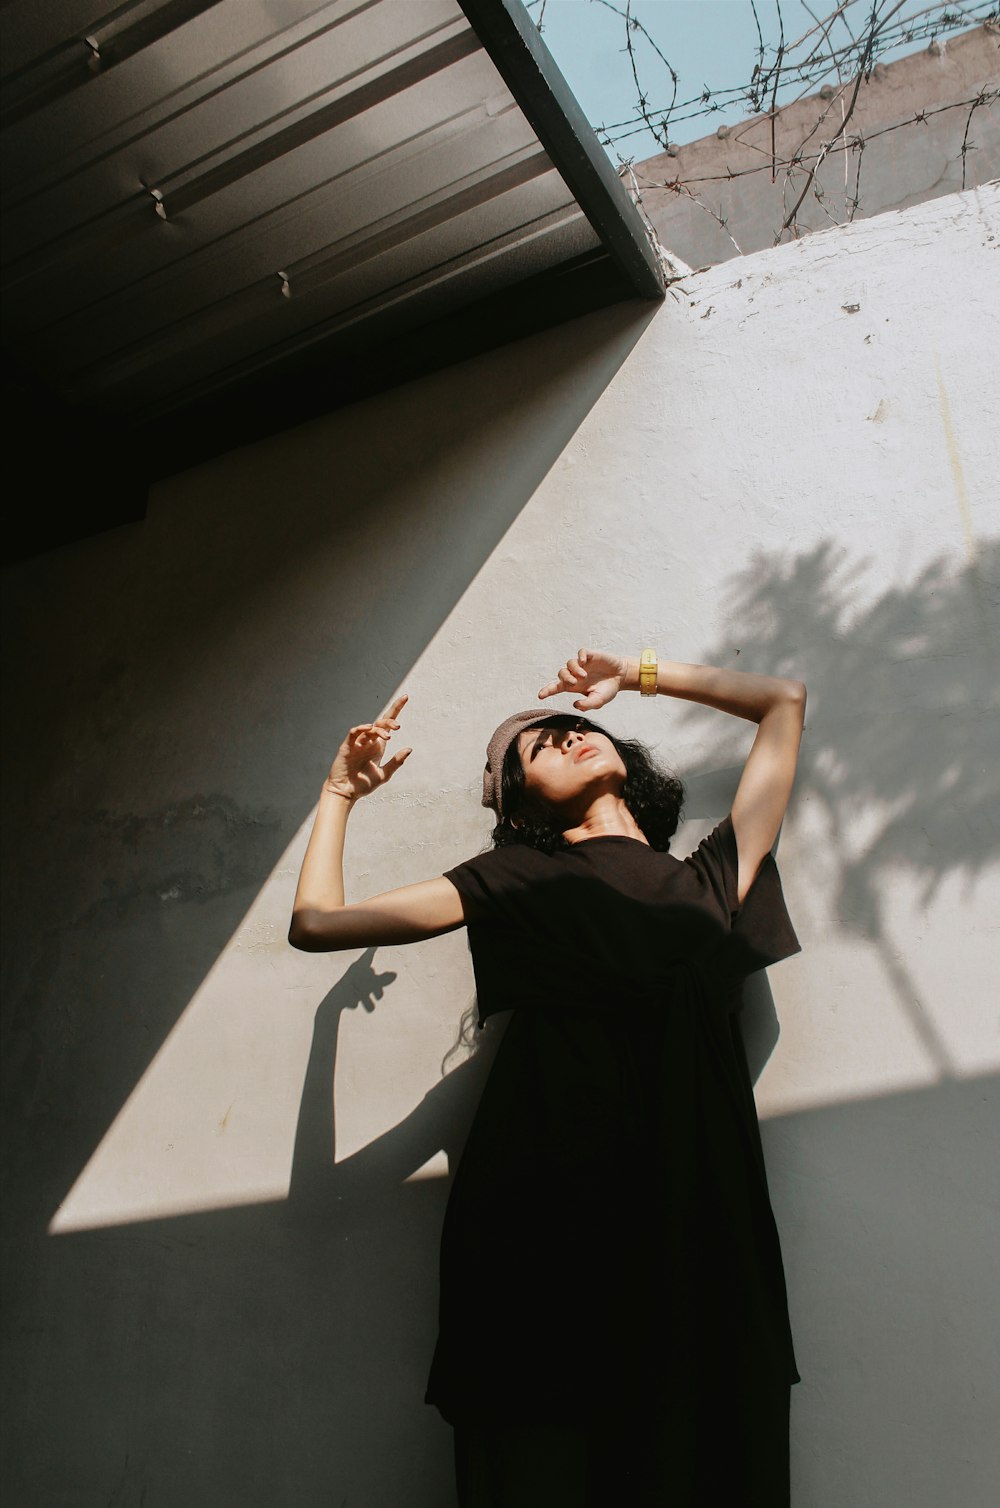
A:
[538, 650, 805, 902]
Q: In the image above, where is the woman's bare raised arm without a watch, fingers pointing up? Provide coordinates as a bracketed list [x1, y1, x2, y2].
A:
[288, 697, 465, 953]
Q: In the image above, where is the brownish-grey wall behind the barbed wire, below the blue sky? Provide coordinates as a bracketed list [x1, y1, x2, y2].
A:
[635, 24, 1000, 267]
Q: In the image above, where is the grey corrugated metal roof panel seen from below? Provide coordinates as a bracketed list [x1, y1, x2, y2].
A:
[3, 0, 621, 418]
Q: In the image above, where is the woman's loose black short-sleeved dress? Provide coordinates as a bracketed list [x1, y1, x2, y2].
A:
[427, 817, 799, 1508]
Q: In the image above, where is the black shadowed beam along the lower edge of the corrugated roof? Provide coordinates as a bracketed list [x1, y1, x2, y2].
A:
[2, 250, 637, 566]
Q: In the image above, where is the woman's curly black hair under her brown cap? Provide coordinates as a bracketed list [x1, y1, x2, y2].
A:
[490, 715, 685, 854]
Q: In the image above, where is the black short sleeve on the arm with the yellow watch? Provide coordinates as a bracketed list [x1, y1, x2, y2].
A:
[685, 816, 801, 977]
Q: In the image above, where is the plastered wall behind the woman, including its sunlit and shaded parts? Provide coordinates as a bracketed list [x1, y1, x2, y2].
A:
[5, 190, 1000, 1508]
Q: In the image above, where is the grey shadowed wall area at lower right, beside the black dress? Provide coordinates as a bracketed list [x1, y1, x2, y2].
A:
[778, 1074, 1000, 1508]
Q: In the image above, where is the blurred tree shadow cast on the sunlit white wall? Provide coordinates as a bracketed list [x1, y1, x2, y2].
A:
[682, 540, 1000, 1077]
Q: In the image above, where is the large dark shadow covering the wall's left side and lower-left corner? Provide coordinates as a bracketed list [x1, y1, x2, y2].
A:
[3, 305, 655, 1508]
